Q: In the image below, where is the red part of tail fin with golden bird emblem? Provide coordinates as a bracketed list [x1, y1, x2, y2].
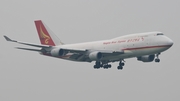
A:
[35, 20, 55, 46]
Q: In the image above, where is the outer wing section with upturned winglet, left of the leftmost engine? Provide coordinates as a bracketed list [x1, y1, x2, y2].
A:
[4, 36, 51, 48]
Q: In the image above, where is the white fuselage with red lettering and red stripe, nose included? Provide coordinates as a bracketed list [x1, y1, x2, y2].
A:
[50, 32, 173, 62]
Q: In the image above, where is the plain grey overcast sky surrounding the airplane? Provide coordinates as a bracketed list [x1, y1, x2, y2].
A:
[0, 0, 180, 101]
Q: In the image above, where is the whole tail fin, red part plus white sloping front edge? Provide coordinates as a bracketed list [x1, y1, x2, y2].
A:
[34, 20, 63, 46]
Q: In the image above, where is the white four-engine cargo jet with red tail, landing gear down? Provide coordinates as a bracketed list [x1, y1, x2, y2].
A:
[4, 20, 173, 70]
